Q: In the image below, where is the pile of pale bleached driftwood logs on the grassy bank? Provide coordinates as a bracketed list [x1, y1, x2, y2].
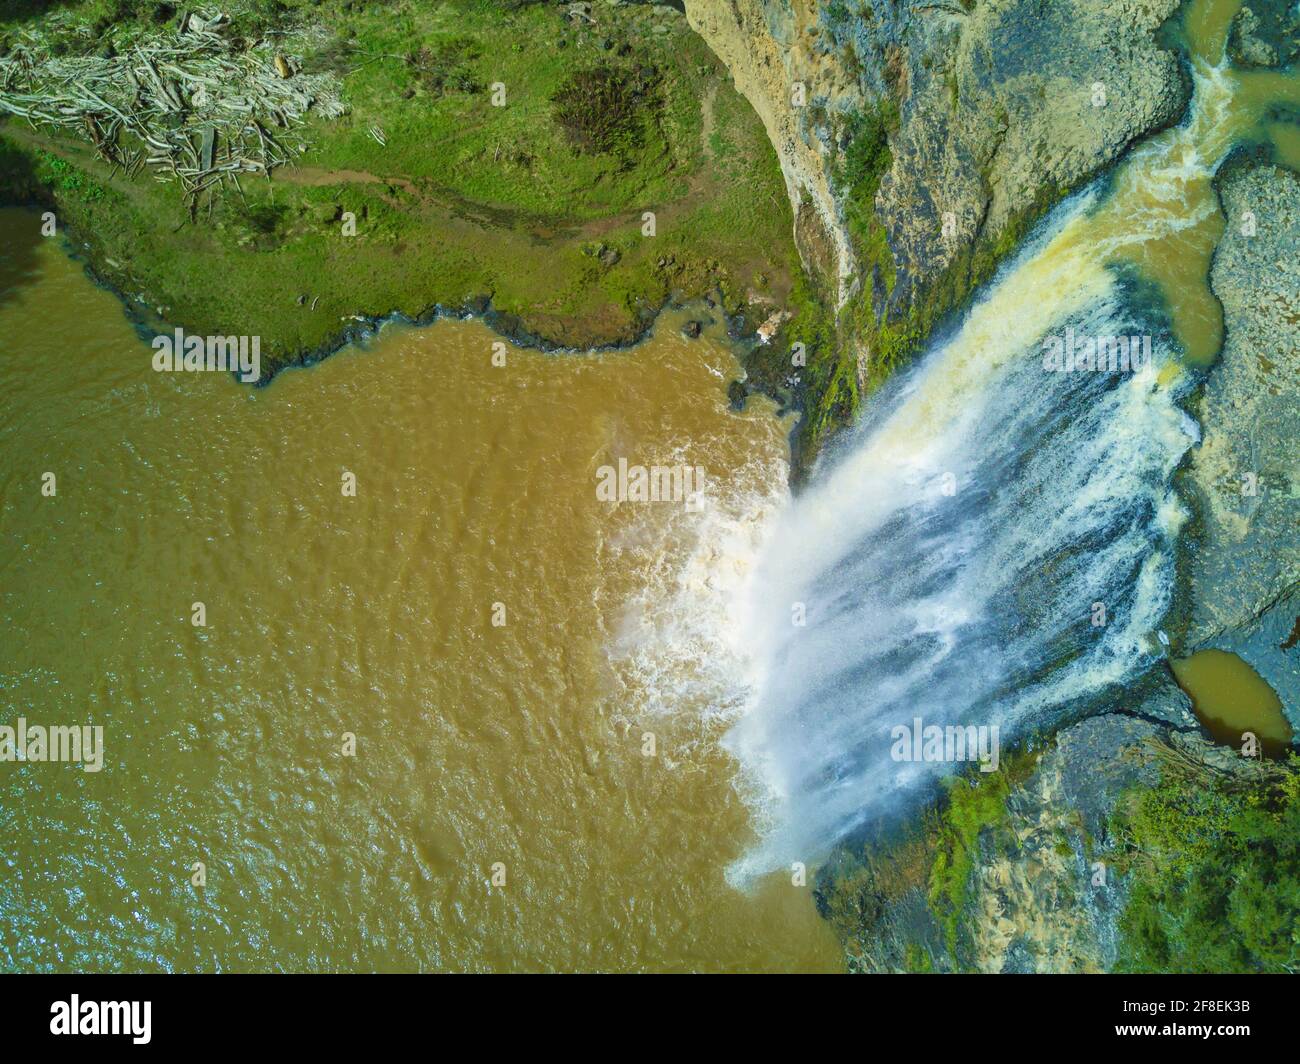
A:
[0, 14, 346, 215]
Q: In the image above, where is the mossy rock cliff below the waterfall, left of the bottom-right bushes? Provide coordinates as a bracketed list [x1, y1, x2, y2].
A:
[816, 714, 1296, 973]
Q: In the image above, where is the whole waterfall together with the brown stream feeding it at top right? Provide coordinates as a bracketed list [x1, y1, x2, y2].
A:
[728, 1, 1300, 879]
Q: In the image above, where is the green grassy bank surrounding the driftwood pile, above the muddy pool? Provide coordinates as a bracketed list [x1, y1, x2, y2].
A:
[0, 0, 798, 377]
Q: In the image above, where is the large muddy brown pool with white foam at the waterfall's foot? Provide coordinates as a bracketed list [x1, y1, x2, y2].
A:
[0, 211, 841, 970]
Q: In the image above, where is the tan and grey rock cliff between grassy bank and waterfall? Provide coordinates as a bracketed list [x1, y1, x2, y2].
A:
[685, 0, 1187, 340]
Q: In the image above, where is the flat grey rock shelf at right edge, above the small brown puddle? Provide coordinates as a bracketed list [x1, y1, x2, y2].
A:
[1184, 165, 1300, 728]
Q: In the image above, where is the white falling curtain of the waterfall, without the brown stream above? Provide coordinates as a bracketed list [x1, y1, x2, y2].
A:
[732, 199, 1195, 868]
